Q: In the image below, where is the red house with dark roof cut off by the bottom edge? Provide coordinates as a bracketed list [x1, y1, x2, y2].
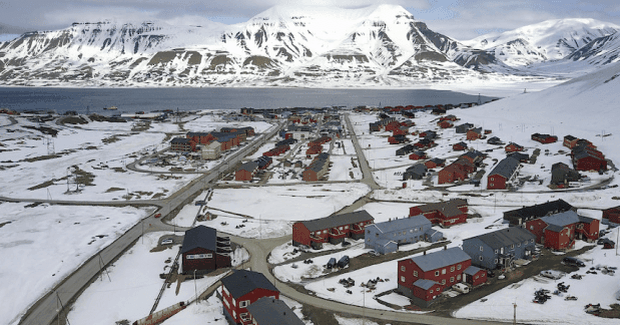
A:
[221, 270, 280, 325]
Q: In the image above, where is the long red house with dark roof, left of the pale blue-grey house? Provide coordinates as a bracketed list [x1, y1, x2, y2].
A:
[293, 210, 375, 248]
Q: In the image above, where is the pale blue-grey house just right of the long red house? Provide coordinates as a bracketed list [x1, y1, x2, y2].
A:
[364, 215, 443, 254]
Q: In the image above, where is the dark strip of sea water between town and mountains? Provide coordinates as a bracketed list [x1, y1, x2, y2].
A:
[0, 87, 491, 114]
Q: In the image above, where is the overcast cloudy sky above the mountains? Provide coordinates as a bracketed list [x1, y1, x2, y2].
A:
[0, 0, 620, 40]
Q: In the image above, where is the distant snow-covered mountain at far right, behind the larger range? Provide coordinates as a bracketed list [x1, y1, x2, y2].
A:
[463, 18, 620, 67]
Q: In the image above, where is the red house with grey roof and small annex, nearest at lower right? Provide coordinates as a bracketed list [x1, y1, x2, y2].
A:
[397, 247, 471, 307]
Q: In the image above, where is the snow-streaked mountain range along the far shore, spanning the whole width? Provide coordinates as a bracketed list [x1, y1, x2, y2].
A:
[0, 5, 615, 87]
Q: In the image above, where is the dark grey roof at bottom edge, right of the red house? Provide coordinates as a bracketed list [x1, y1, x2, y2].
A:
[248, 297, 304, 325]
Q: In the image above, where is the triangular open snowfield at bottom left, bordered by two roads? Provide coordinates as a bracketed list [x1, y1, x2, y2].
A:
[0, 203, 154, 324]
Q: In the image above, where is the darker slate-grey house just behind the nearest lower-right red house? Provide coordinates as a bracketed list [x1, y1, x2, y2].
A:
[463, 227, 536, 270]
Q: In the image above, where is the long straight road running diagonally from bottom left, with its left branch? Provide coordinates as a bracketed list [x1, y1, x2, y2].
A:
[16, 119, 284, 325]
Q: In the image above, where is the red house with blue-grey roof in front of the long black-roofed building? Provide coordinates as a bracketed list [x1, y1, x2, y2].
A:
[525, 210, 599, 250]
